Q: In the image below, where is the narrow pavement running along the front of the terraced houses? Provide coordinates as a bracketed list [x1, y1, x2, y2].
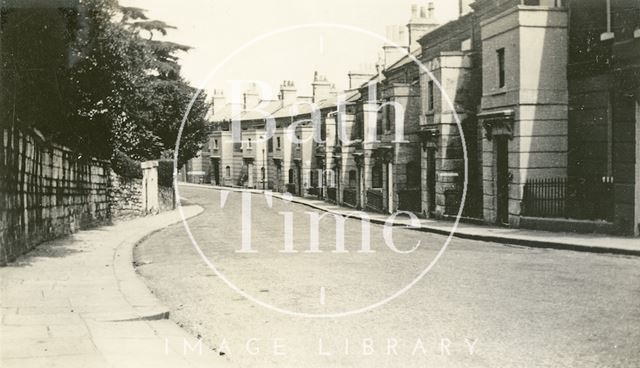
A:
[180, 183, 640, 256]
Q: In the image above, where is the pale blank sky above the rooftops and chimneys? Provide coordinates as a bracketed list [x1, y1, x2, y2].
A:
[120, 0, 458, 103]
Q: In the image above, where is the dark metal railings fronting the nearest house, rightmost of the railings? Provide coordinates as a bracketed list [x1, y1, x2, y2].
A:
[522, 176, 614, 221]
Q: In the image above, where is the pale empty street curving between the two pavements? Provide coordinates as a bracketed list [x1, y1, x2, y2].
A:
[135, 187, 640, 367]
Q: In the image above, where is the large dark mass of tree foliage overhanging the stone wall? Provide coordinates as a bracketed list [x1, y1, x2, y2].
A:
[0, 0, 209, 165]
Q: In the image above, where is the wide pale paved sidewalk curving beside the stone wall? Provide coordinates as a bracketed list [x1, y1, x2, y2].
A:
[0, 206, 228, 368]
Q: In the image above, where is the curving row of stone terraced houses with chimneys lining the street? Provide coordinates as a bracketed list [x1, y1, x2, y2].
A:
[182, 0, 640, 235]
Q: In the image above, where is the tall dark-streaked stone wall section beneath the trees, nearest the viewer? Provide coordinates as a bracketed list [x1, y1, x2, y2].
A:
[0, 128, 111, 265]
